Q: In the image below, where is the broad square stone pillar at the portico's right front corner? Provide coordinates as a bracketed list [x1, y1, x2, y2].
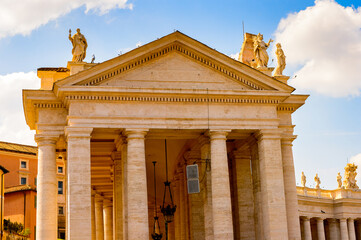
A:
[257, 129, 288, 240]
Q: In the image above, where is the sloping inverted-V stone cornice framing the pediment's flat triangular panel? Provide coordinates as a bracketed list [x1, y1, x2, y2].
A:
[54, 32, 294, 94]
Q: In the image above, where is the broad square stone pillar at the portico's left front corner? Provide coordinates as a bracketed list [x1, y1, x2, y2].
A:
[65, 127, 93, 240]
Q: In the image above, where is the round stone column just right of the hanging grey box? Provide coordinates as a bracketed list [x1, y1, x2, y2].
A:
[209, 131, 233, 239]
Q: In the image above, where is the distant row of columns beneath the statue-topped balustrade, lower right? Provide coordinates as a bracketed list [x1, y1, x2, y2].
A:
[300, 216, 361, 240]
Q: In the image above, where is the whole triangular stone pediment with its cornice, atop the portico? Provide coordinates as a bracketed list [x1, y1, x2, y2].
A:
[55, 32, 294, 93]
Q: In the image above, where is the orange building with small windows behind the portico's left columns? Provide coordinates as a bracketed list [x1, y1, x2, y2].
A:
[0, 142, 65, 240]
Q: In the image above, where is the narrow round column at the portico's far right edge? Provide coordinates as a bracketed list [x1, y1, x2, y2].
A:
[281, 135, 301, 240]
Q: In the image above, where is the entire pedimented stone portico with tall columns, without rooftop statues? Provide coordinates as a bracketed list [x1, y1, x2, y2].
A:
[23, 32, 308, 240]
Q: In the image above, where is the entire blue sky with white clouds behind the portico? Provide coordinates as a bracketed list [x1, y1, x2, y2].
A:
[0, 0, 361, 189]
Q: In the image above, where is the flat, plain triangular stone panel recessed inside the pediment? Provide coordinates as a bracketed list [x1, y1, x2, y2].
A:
[99, 52, 253, 90]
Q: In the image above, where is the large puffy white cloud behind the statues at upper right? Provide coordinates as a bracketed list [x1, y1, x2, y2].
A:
[273, 0, 361, 97]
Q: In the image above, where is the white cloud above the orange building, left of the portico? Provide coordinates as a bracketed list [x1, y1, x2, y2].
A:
[0, 72, 40, 145]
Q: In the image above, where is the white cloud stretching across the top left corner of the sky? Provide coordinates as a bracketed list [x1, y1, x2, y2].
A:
[0, 0, 133, 39]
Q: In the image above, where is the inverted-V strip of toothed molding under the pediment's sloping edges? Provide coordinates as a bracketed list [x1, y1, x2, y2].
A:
[77, 43, 265, 90]
